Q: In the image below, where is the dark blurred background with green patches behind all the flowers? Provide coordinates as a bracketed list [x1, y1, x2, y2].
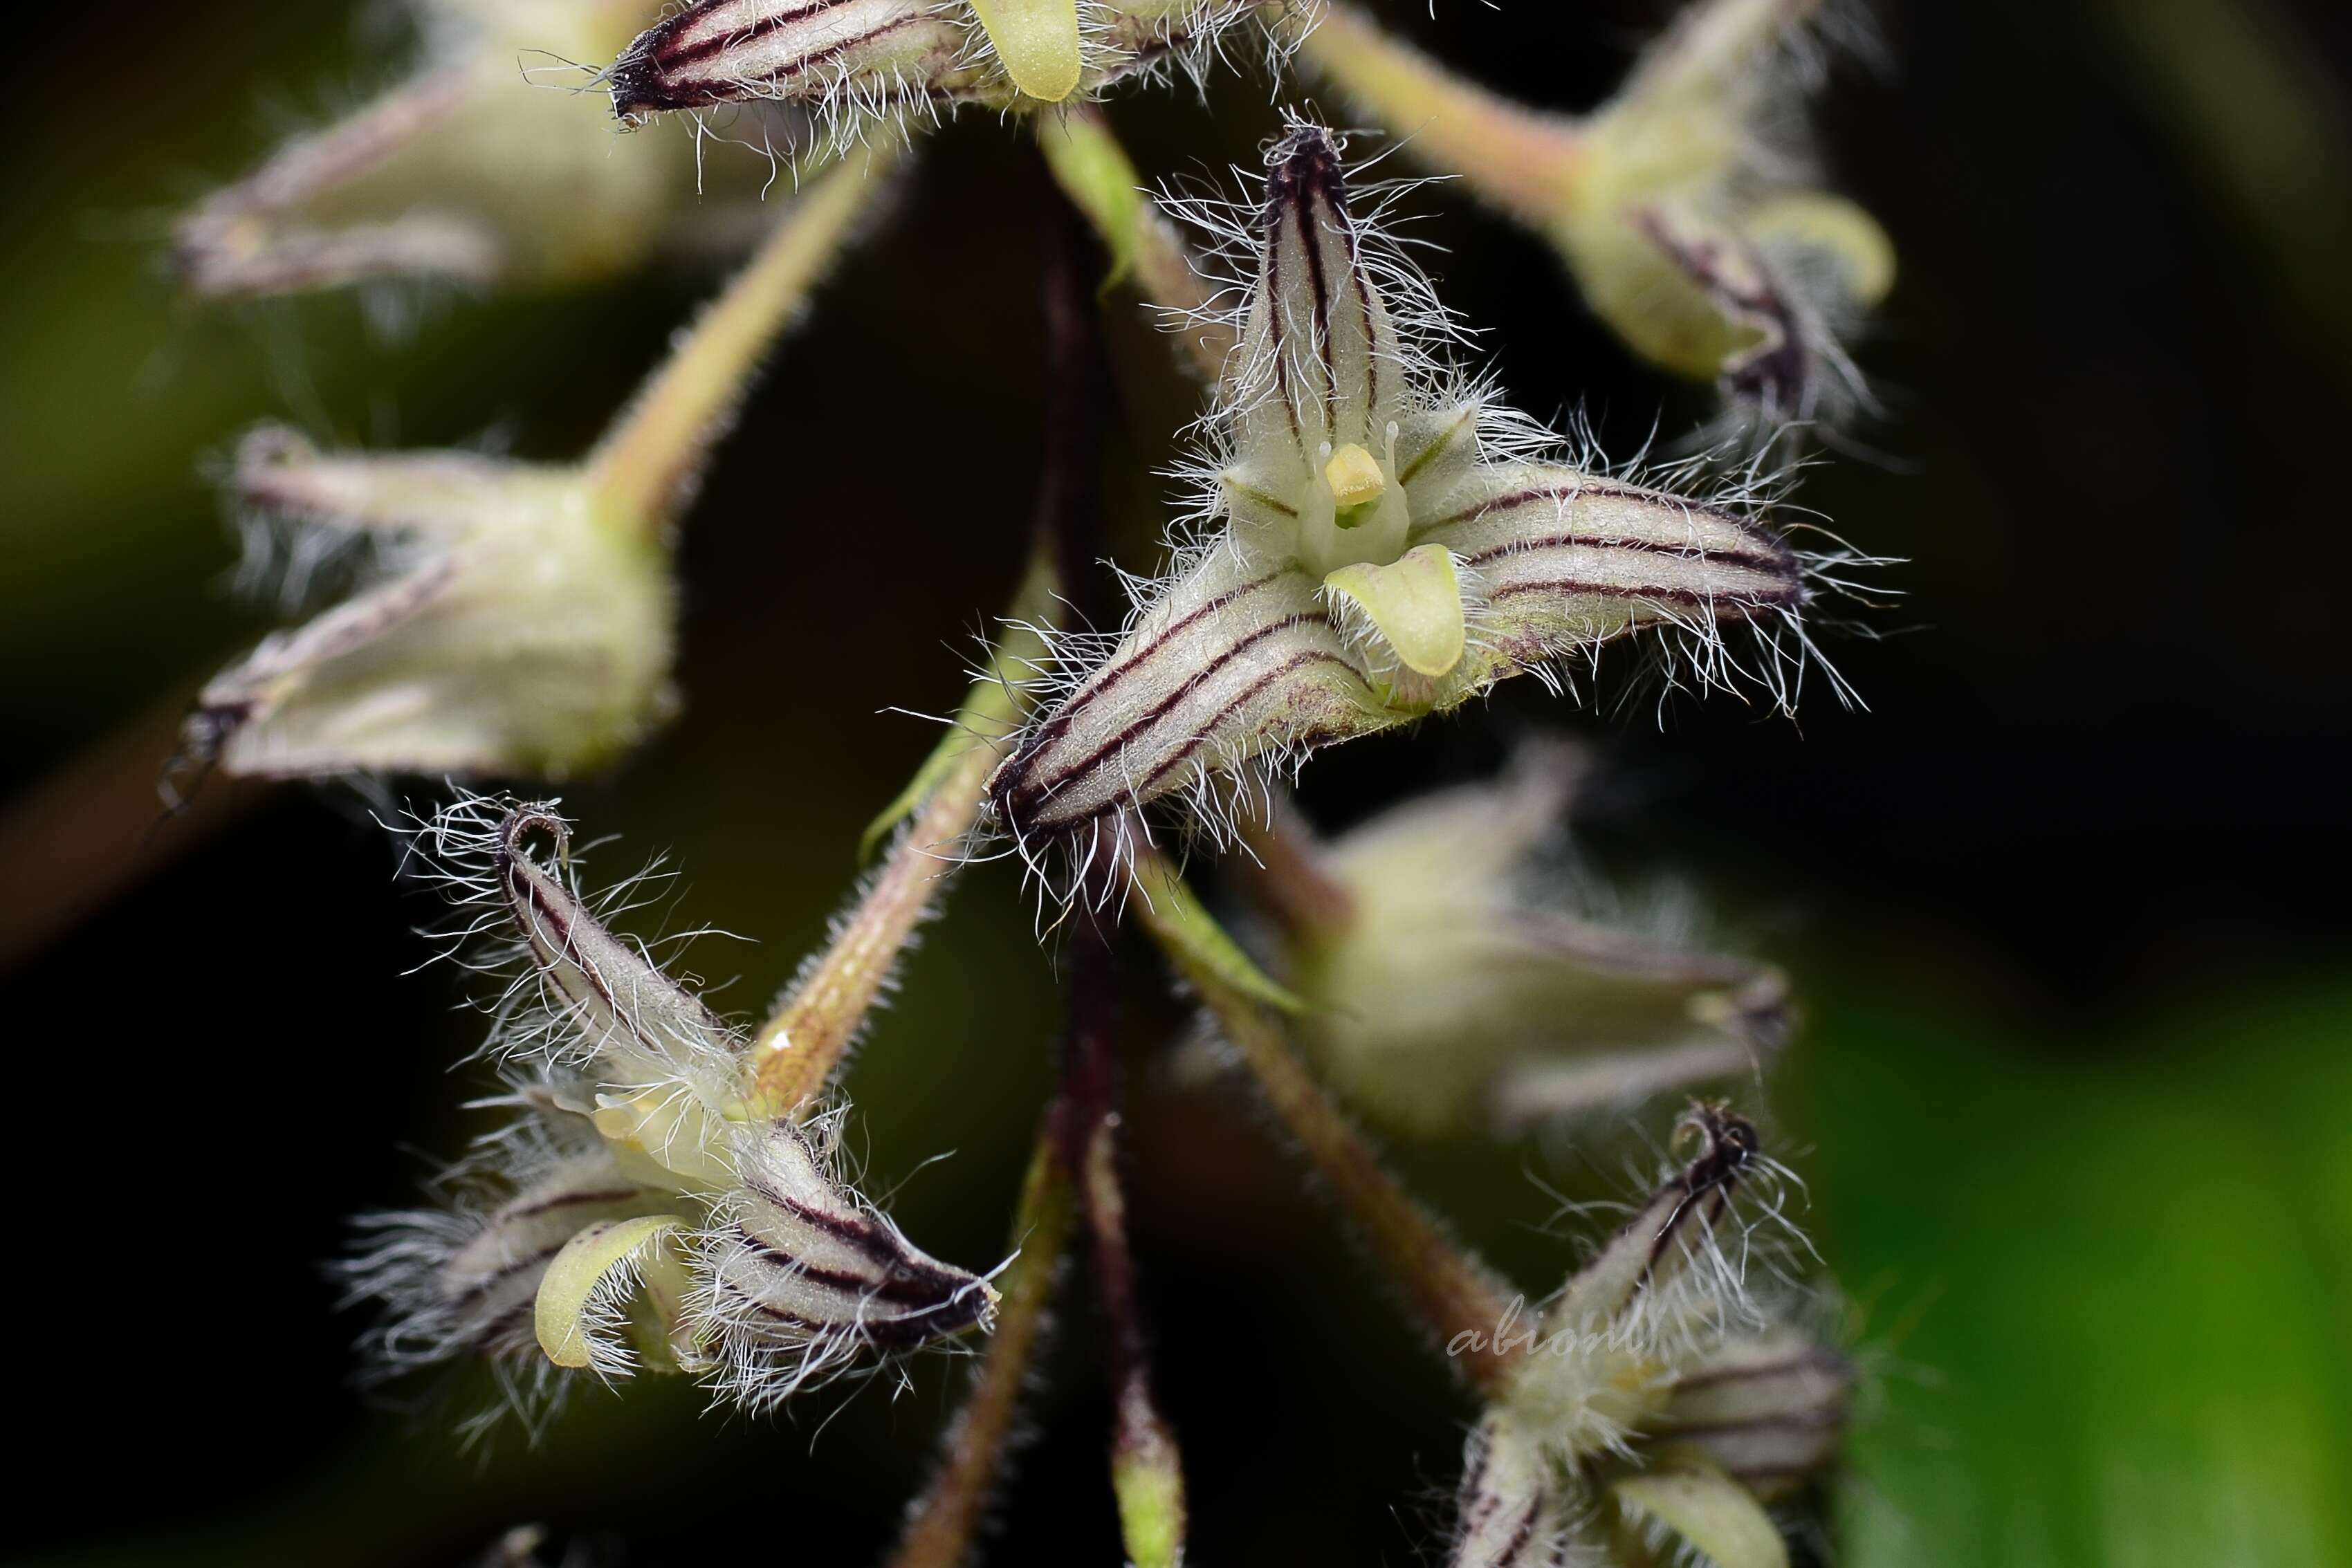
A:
[0, 0, 2352, 1568]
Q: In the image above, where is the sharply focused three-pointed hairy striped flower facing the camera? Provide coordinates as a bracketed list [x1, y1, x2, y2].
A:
[990, 124, 1806, 837]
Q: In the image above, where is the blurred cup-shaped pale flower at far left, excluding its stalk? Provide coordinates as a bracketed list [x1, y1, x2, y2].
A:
[186, 430, 675, 778]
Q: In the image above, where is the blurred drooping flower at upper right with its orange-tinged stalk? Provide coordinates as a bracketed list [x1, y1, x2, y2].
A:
[1298, 0, 1895, 421]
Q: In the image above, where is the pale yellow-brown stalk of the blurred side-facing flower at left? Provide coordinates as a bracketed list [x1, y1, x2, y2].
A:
[588, 148, 896, 534]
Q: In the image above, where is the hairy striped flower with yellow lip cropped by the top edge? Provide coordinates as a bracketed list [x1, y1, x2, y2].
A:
[612, 0, 1312, 141]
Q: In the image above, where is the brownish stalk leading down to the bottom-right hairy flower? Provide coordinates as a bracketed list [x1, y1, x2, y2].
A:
[1131, 851, 1519, 1394]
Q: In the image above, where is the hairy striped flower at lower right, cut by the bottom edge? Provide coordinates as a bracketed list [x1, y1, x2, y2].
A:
[1451, 1105, 1853, 1568]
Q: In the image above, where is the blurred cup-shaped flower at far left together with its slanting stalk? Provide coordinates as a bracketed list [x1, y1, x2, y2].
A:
[183, 155, 889, 778]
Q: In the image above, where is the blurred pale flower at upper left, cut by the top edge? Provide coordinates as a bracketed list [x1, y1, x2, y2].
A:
[172, 0, 795, 296]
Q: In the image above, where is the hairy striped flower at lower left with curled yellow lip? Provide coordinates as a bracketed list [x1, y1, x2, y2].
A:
[346, 800, 995, 1408]
